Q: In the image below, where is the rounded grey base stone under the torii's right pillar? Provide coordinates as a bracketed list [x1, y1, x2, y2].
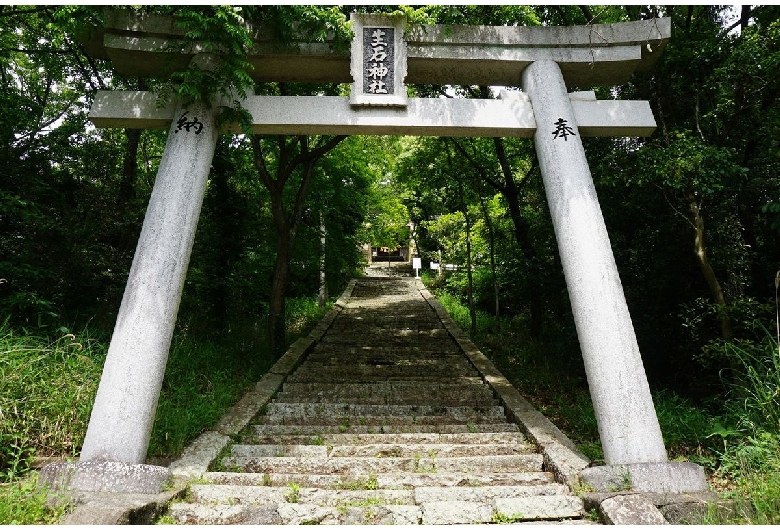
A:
[579, 462, 709, 493]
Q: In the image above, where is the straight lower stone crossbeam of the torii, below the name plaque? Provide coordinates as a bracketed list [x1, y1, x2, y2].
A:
[89, 91, 655, 138]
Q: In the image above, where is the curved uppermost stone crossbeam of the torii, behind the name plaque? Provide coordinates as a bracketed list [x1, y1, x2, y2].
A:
[86, 10, 671, 87]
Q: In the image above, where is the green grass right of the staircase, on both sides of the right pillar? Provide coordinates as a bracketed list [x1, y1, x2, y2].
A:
[436, 282, 780, 524]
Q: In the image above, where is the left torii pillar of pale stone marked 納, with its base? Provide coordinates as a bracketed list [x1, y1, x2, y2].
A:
[40, 56, 218, 491]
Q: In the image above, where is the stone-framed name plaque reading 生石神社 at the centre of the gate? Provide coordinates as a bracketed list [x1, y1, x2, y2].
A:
[350, 13, 407, 107]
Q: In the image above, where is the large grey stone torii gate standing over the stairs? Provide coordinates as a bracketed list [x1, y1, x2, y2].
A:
[56, 12, 706, 491]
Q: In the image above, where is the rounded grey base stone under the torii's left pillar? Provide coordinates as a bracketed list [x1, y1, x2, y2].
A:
[40, 461, 173, 493]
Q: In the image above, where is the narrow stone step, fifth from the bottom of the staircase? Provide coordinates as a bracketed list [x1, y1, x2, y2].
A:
[231, 443, 535, 458]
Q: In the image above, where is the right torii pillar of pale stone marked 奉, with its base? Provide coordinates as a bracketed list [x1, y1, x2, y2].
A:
[522, 60, 706, 491]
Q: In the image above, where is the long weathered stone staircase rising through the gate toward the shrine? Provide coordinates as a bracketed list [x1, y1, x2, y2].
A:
[163, 277, 591, 524]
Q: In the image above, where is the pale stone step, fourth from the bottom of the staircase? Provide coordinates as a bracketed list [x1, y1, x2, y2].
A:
[222, 454, 543, 474]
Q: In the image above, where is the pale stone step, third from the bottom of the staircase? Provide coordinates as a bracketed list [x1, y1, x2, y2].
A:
[203, 471, 555, 490]
